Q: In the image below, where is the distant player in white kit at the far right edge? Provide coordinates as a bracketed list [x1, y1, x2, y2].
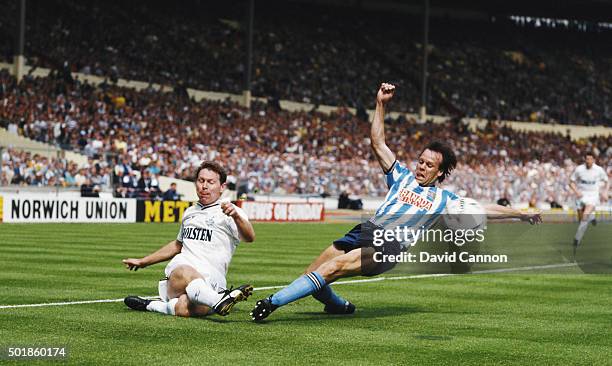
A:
[570, 153, 609, 256]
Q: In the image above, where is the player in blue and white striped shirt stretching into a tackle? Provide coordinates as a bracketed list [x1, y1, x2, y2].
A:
[251, 83, 541, 321]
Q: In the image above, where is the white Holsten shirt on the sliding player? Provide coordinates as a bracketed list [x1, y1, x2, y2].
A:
[176, 201, 247, 277]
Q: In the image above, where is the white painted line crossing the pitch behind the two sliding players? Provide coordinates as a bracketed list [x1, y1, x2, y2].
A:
[0, 263, 578, 309]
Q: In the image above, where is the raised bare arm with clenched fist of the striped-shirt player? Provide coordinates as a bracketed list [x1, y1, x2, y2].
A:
[370, 83, 395, 173]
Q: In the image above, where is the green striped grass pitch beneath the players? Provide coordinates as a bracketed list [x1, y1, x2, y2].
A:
[0, 224, 612, 365]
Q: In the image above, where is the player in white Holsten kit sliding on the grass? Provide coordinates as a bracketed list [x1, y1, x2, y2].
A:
[123, 161, 255, 317]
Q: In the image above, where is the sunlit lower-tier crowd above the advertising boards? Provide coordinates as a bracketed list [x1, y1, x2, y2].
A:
[0, 71, 612, 202]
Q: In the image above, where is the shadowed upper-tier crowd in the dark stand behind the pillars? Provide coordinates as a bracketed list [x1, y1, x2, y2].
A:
[0, 0, 612, 125]
